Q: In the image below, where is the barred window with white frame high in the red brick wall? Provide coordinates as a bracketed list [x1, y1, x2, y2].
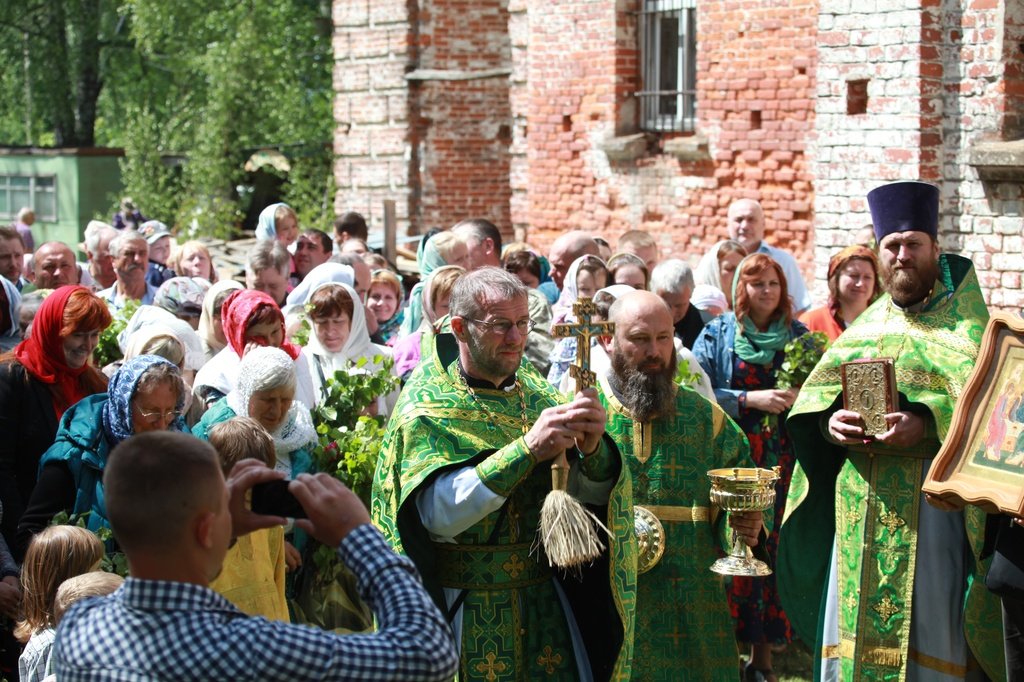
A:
[637, 0, 697, 132]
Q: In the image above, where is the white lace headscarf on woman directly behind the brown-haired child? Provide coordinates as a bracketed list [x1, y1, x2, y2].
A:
[227, 346, 316, 466]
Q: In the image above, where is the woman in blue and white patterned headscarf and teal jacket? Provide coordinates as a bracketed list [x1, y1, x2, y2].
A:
[17, 355, 186, 551]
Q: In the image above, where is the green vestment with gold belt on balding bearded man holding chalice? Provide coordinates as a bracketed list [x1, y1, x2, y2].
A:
[601, 377, 753, 682]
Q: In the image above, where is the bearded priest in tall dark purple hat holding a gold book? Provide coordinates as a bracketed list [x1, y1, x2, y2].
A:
[778, 182, 1002, 680]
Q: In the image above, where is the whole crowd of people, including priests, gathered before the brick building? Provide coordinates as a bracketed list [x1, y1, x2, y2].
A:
[0, 182, 1021, 682]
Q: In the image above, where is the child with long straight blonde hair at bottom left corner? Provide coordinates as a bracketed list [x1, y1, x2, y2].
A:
[14, 525, 103, 680]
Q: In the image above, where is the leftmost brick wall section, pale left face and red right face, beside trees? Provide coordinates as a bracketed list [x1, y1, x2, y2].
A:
[334, 0, 512, 232]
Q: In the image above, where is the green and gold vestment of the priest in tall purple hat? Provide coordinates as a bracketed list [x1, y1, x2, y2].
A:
[777, 254, 1002, 680]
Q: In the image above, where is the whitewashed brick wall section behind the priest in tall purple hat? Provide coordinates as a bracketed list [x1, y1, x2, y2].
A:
[813, 0, 1024, 309]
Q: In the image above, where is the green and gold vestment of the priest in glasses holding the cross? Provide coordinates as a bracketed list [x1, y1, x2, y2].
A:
[371, 334, 636, 681]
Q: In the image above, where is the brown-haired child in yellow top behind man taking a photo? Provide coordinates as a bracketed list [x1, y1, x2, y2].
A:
[210, 417, 290, 623]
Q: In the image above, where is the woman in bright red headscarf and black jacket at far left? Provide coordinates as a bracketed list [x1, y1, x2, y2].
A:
[0, 287, 111, 556]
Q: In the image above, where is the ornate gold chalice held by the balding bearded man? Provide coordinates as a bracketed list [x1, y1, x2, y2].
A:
[708, 467, 779, 577]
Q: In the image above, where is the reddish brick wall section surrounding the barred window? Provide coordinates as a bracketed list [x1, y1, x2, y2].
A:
[513, 0, 817, 272]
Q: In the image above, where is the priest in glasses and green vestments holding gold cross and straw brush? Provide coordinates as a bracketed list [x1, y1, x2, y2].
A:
[372, 267, 636, 681]
